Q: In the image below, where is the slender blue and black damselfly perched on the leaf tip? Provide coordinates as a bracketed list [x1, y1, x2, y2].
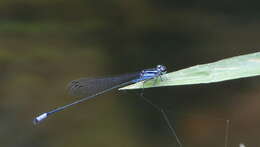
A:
[33, 65, 166, 124]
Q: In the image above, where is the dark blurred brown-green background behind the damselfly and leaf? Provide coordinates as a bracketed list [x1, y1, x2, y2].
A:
[0, 0, 260, 147]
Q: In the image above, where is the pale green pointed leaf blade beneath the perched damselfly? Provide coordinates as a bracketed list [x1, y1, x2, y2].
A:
[119, 52, 260, 90]
